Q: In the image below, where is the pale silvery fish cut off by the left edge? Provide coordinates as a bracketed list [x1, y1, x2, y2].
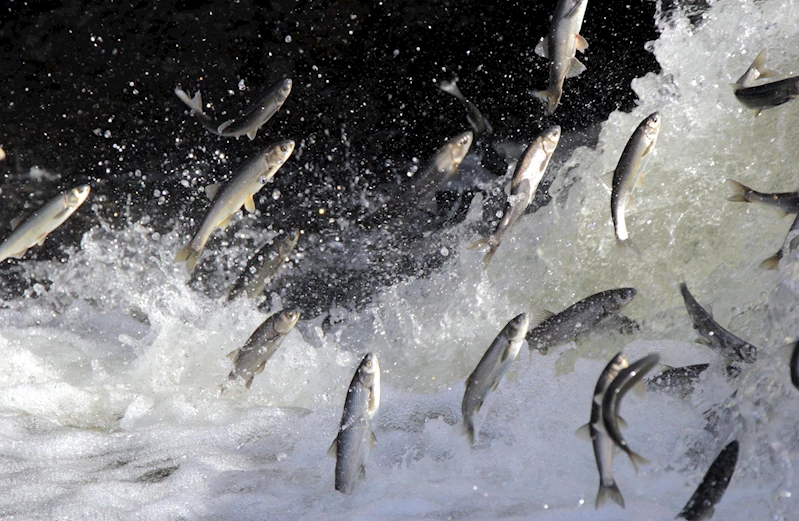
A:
[0, 185, 91, 262]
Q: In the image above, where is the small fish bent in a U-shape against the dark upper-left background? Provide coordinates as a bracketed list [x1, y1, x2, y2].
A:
[175, 78, 291, 141]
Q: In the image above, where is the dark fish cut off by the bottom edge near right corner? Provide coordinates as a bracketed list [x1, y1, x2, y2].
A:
[677, 440, 738, 521]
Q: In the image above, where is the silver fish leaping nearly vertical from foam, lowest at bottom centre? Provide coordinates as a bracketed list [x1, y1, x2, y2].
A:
[328, 353, 380, 494]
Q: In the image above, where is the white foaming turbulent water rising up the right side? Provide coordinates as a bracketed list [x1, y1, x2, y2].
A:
[0, 0, 799, 520]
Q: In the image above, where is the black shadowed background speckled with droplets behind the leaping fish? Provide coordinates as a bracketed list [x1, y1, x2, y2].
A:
[0, 0, 658, 315]
